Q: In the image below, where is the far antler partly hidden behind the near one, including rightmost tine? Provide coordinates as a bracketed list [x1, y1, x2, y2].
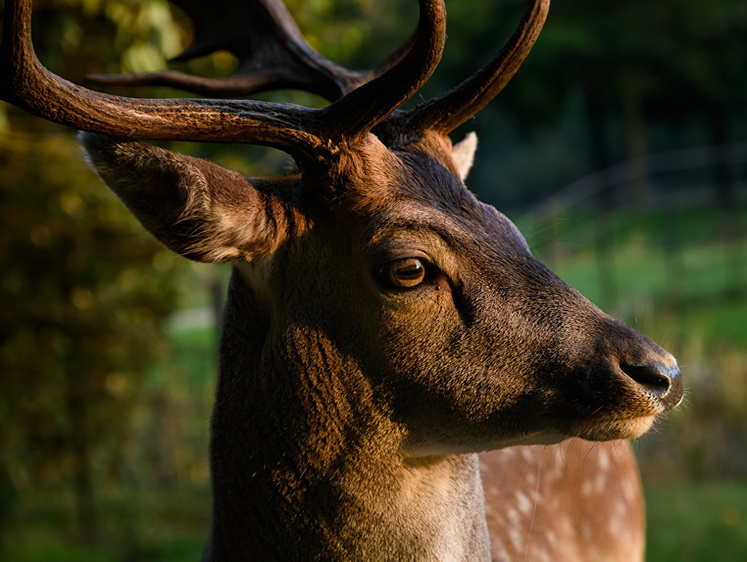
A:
[102, 0, 550, 140]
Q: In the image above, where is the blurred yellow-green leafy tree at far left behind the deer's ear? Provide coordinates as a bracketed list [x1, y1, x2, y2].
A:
[0, 0, 186, 538]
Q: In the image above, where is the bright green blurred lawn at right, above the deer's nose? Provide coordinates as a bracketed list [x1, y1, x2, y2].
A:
[519, 203, 747, 324]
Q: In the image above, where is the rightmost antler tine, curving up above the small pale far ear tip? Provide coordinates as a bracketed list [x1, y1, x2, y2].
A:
[398, 0, 550, 134]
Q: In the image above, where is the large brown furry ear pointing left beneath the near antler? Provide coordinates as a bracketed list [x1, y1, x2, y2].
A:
[80, 133, 303, 262]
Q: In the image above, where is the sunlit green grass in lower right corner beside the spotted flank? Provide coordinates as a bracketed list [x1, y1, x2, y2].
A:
[646, 476, 747, 562]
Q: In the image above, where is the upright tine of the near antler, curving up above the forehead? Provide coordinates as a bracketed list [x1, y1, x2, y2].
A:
[322, 0, 446, 138]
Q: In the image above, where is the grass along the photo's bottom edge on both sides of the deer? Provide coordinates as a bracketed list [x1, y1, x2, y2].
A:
[0, 482, 747, 562]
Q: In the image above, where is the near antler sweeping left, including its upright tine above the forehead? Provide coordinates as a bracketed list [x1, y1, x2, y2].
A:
[0, 0, 446, 154]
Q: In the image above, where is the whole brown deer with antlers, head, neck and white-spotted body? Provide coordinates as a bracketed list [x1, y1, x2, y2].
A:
[0, 0, 683, 561]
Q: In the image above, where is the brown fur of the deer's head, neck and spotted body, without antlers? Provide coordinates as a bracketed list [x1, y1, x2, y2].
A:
[85, 127, 680, 560]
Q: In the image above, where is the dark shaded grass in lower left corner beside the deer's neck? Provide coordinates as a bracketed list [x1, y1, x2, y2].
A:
[0, 488, 210, 562]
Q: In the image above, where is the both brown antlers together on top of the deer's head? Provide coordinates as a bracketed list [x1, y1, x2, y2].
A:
[0, 0, 549, 152]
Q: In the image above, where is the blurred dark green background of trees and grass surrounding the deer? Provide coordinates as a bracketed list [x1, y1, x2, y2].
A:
[0, 0, 747, 561]
